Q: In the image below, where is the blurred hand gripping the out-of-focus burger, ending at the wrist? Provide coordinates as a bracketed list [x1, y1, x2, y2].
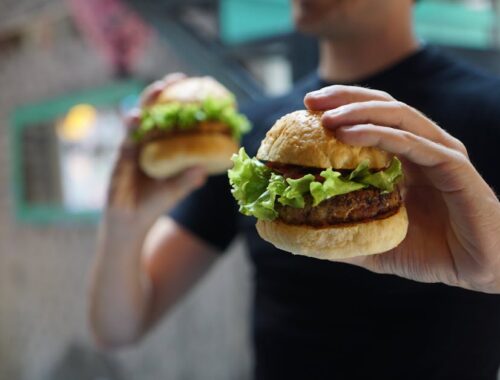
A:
[106, 73, 206, 225]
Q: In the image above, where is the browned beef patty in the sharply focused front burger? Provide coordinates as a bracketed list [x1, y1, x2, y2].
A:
[276, 188, 401, 227]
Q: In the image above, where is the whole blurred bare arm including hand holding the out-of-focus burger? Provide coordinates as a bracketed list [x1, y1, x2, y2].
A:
[89, 74, 216, 347]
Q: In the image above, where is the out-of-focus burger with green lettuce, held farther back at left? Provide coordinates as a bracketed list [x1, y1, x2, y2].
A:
[132, 77, 250, 179]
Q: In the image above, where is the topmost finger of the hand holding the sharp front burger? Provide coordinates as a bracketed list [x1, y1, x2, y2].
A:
[304, 85, 394, 111]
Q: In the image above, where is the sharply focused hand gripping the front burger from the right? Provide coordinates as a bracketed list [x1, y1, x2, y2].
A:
[305, 86, 500, 293]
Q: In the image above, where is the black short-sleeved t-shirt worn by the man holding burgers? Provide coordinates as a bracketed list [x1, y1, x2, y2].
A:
[171, 47, 500, 380]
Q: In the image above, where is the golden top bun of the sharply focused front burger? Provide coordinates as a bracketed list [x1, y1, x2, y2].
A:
[257, 110, 392, 170]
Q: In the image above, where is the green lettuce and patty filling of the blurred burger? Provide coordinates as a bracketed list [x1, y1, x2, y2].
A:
[132, 98, 250, 143]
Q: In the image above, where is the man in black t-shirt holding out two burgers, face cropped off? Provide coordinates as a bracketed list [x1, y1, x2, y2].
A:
[90, 0, 500, 379]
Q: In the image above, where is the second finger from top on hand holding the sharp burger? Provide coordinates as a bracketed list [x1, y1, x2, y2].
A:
[322, 100, 466, 154]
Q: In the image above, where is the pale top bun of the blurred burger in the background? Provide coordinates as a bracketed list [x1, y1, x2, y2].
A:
[156, 76, 233, 103]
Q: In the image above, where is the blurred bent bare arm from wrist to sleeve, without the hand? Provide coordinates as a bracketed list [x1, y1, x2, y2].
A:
[90, 214, 217, 348]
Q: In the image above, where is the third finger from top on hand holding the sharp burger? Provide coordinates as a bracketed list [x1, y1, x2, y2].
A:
[335, 124, 473, 193]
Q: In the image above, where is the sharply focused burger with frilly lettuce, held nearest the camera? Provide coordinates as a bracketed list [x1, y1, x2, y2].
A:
[228, 111, 408, 260]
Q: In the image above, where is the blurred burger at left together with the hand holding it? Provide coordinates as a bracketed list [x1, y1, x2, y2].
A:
[106, 73, 249, 228]
